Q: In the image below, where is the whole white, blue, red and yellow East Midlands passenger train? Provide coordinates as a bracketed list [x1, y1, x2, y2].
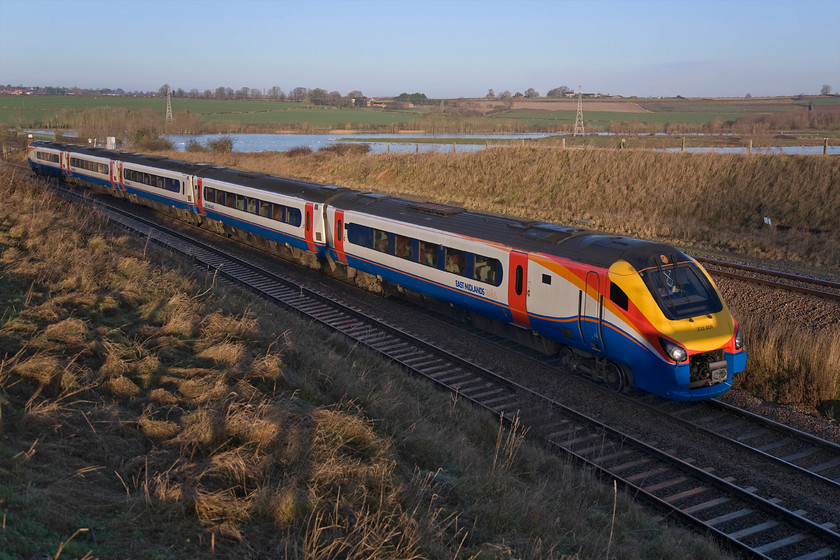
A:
[27, 141, 747, 401]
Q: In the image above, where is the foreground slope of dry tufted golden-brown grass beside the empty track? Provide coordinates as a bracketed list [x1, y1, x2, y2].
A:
[0, 173, 720, 560]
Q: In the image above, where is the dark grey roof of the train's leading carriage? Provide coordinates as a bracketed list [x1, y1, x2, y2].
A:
[330, 192, 689, 270]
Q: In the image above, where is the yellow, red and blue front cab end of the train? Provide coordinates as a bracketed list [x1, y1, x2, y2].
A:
[606, 255, 747, 401]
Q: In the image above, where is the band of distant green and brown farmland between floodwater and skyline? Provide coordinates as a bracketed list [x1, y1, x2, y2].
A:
[0, 96, 840, 133]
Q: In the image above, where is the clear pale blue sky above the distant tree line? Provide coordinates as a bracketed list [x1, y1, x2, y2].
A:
[0, 0, 840, 98]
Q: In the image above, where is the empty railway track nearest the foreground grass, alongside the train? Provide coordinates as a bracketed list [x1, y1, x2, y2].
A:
[47, 182, 840, 560]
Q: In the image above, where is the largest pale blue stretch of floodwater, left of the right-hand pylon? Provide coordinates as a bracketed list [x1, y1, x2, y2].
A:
[167, 133, 552, 154]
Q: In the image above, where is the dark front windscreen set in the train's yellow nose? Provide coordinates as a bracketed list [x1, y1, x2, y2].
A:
[640, 255, 723, 320]
